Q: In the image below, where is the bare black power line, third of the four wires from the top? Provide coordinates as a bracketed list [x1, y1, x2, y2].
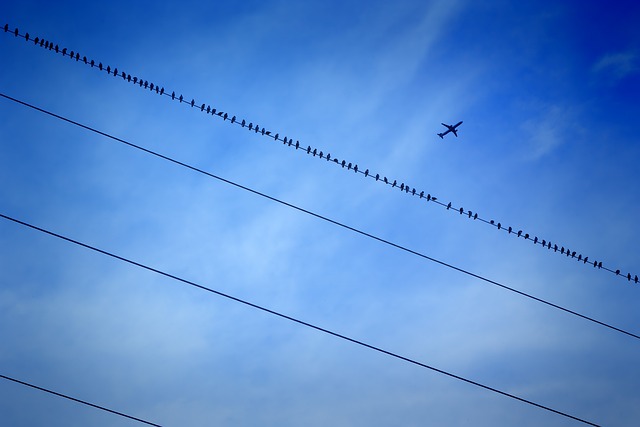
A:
[0, 213, 598, 426]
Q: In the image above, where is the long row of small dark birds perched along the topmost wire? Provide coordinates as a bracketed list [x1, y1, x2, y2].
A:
[4, 24, 639, 283]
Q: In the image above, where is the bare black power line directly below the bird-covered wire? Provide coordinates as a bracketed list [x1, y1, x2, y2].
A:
[0, 92, 640, 339]
